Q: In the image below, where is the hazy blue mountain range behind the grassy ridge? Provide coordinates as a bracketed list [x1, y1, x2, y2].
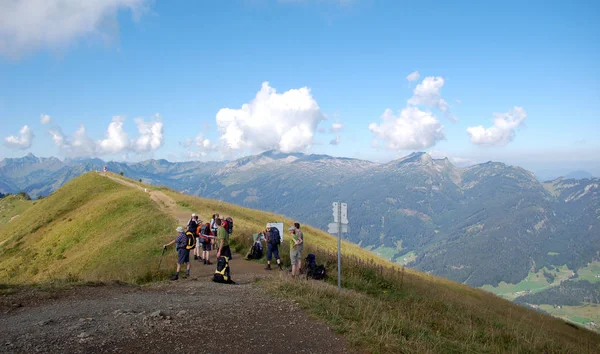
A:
[0, 151, 600, 286]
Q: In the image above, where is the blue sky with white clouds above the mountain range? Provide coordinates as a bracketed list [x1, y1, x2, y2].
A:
[0, 0, 600, 174]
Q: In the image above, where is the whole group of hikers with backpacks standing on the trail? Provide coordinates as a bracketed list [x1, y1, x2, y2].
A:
[163, 214, 304, 282]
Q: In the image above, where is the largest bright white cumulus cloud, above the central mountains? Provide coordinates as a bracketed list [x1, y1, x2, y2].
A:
[216, 82, 326, 152]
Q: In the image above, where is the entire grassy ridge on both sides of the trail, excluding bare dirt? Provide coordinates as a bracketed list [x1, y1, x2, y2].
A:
[0, 173, 600, 353]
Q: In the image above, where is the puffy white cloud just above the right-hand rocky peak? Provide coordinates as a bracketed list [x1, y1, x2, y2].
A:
[369, 107, 444, 150]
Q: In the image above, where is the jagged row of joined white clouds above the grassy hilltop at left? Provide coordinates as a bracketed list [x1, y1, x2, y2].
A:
[48, 114, 163, 157]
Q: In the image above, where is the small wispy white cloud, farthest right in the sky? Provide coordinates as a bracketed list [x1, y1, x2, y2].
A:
[467, 107, 527, 146]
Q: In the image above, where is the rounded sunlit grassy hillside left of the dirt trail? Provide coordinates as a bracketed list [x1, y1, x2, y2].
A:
[0, 173, 175, 283]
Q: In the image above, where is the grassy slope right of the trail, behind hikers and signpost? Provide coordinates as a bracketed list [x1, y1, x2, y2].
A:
[165, 190, 600, 353]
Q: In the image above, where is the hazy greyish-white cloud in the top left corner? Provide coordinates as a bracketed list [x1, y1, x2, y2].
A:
[0, 0, 147, 57]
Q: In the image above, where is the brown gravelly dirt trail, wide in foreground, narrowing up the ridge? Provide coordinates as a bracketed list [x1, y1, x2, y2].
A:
[0, 175, 350, 353]
